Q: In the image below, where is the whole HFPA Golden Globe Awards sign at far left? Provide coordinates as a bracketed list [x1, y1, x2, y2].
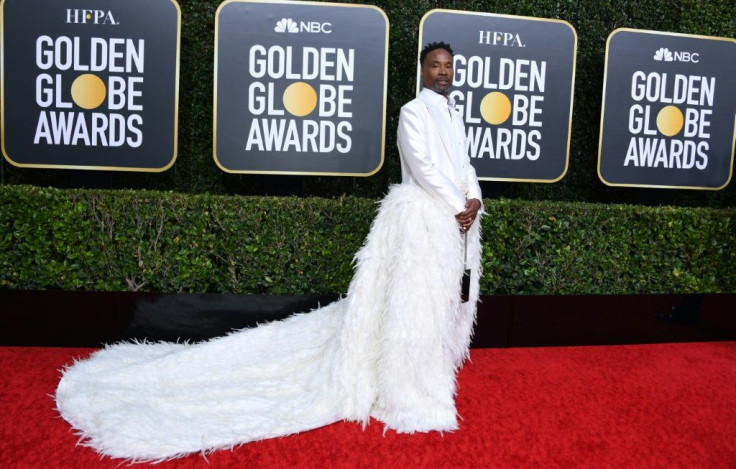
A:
[2, 0, 180, 172]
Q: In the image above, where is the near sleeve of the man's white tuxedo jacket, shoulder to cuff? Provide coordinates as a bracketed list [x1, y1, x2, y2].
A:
[397, 106, 466, 214]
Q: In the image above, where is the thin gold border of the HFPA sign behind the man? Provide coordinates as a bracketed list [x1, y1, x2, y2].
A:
[416, 8, 578, 184]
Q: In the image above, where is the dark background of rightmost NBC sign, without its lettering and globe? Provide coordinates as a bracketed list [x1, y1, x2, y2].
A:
[598, 28, 736, 189]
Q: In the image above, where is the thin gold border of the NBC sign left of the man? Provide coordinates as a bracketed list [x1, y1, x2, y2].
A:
[213, 0, 390, 177]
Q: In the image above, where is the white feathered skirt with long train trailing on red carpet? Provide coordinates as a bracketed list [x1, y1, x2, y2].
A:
[56, 184, 480, 462]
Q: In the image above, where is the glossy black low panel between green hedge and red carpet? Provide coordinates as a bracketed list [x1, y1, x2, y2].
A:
[0, 290, 736, 347]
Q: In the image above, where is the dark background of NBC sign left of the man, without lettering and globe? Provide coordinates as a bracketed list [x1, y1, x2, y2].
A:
[213, 0, 388, 176]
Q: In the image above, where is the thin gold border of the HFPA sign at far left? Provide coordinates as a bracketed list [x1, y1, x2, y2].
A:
[0, 0, 181, 173]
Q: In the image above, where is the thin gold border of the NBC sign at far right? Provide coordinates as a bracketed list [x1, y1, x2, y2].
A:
[597, 28, 736, 191]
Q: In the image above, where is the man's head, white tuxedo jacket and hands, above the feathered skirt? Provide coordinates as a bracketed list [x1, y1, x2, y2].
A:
[398, 42, 482, 232]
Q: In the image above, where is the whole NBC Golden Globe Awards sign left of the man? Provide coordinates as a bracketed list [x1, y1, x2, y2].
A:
[213, 0, 388, 176]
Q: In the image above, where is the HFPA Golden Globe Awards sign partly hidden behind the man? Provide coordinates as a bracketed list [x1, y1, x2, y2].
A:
[417, 10, 577, 182]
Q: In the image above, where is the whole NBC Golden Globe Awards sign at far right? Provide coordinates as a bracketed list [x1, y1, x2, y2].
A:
[598, 29, 736, 190]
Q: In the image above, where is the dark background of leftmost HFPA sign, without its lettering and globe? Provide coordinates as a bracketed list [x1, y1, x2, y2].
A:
[2, 0, 180, 172]
